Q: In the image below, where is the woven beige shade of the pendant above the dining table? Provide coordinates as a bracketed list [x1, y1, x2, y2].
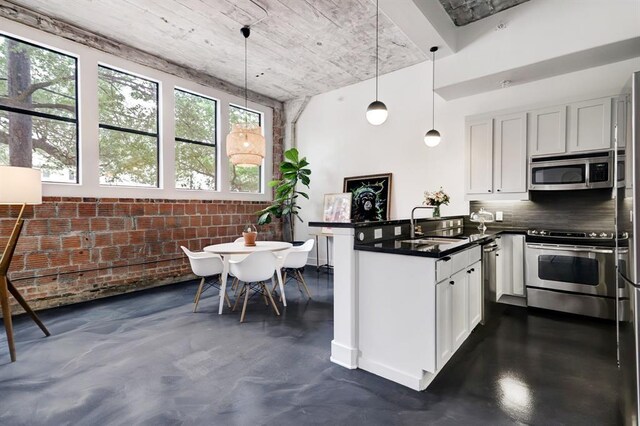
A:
[227, 123, 266, 166]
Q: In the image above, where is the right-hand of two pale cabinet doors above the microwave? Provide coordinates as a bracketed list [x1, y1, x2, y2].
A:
[569, 97, 612, 152]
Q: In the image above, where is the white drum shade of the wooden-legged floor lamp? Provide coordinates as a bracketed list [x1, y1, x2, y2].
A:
[0, 166, 42, 204]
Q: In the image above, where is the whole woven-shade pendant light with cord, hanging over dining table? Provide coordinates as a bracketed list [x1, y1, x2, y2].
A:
[227, 25, 266, 166]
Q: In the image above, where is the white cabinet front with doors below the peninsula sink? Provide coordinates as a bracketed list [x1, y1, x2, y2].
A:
[436, 259, 482, 370]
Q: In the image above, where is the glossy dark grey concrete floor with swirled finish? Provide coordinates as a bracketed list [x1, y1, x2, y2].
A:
[0, 270, 619, 425]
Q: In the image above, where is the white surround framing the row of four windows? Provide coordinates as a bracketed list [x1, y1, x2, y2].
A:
[0, 22, 272, 203]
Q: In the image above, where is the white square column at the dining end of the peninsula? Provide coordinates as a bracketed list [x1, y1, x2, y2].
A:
[331, 228, 358, 369]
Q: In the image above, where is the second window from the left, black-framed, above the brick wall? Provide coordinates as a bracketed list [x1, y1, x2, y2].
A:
[98, 66, 159, 187]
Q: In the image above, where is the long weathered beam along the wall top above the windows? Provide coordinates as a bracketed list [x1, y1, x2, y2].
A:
[0, 0, 283, 110]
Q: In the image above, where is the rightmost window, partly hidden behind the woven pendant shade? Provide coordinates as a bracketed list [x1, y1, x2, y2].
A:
[229, 105, 262, 193]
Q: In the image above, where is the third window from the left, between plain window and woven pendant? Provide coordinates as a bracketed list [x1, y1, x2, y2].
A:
[175, 89, 217, 190]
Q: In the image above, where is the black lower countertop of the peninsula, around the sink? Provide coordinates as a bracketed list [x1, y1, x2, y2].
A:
[354, 228, 526, 258]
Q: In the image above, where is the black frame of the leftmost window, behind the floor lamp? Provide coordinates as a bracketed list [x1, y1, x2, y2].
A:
[0, 31, 81, 185]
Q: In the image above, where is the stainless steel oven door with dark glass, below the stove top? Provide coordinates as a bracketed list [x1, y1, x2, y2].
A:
[526, 243, 616, 297]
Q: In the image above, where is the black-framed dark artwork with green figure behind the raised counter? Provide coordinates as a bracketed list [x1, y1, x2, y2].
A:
[343, 173, 391, 222]
